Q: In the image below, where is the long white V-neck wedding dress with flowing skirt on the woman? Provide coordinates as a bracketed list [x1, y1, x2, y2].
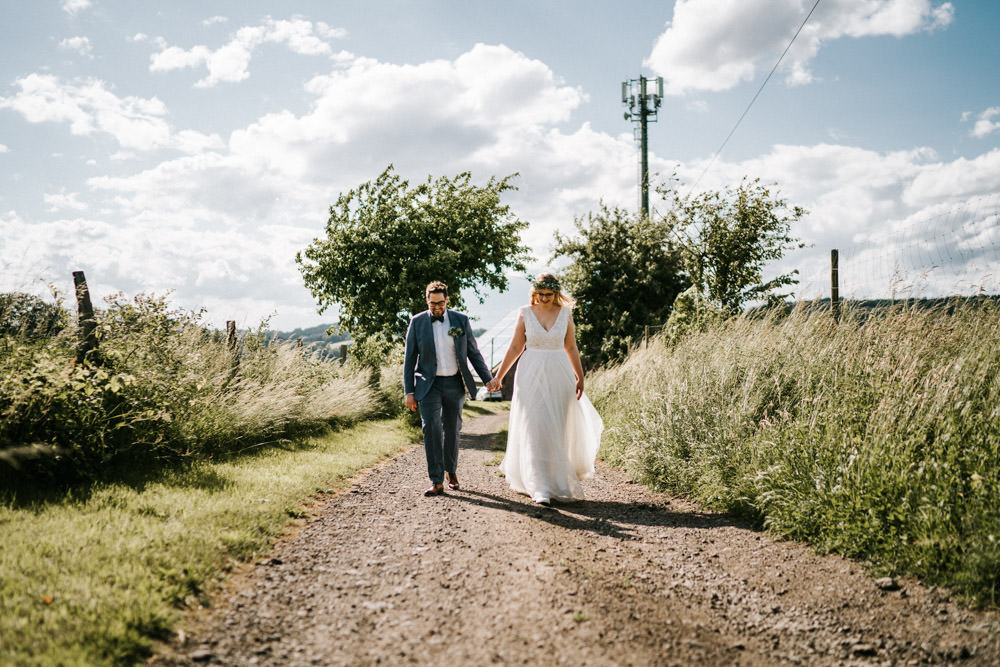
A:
[500, 306, 604, 502]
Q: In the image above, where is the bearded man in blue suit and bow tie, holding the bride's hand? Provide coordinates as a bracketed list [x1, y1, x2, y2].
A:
[403, 281, 492, 496]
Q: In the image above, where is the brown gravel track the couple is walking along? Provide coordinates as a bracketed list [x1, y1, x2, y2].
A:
[151, 414, 1000, 665]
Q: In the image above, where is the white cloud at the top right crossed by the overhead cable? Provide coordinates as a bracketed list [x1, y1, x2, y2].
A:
[644, 0, 954, 95]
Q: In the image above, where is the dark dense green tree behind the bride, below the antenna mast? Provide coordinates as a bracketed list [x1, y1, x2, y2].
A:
[554, 203, 687, 364]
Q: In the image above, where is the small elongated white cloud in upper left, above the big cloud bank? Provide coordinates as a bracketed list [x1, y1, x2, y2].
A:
[149, 18, 346, 88]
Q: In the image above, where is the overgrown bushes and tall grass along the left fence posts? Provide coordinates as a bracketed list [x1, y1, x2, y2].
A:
[0, 295, 379, 483]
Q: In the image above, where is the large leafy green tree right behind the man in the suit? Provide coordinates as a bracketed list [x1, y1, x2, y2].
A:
[295, 165, 528, 361]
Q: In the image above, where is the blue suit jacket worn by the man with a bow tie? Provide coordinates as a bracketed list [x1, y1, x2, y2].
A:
[403, 309, 493, 401]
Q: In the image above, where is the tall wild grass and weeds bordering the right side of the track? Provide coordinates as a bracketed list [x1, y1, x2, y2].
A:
[588, 303, 1000, 607]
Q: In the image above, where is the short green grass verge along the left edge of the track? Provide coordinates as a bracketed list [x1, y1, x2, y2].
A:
[0, 420, 419, 665]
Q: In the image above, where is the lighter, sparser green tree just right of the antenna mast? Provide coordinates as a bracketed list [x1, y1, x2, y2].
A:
[657, 178, 807, 313]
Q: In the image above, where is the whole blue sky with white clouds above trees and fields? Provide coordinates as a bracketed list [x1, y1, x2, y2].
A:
[0, 0, 1000, 329]
